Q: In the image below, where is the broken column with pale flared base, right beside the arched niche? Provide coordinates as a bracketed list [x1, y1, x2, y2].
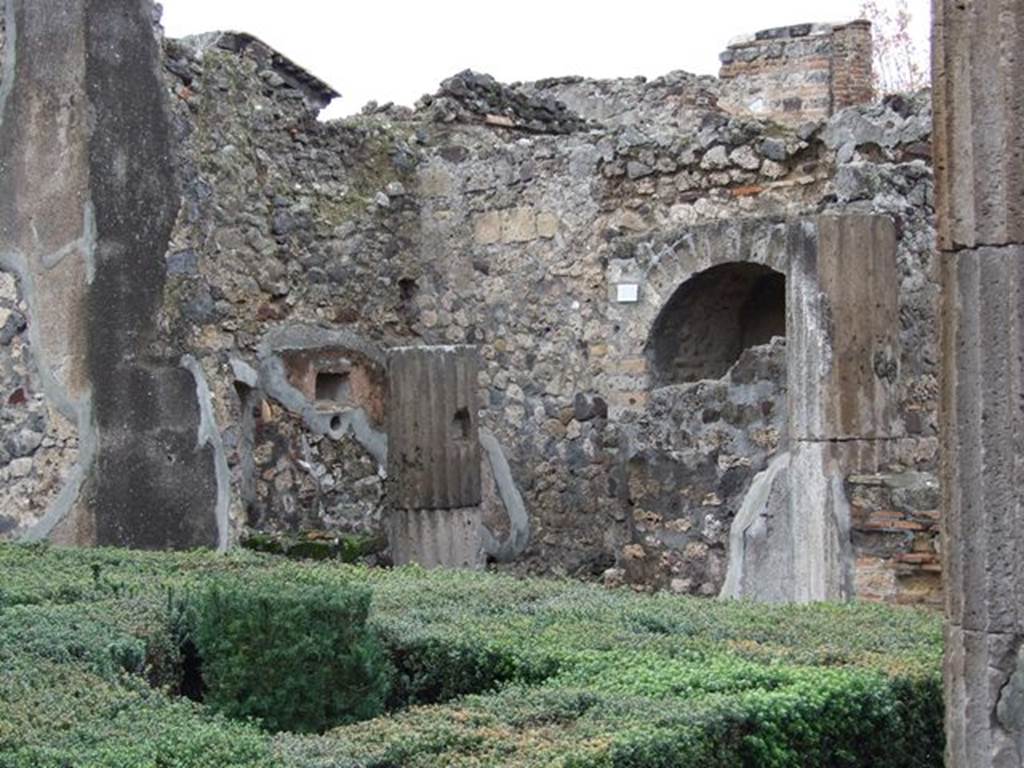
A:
[722, 214, 899, 603]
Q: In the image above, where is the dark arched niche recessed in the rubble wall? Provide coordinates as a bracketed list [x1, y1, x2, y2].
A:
[647, 262, 785, 386]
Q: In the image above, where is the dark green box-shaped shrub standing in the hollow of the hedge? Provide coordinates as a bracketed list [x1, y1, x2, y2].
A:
[183, 577, 392, 732]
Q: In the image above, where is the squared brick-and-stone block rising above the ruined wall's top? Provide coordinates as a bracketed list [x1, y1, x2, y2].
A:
[720, 20, 872, 126]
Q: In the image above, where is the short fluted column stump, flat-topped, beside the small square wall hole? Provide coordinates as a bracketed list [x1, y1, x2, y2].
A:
[387, 346, 483, 567]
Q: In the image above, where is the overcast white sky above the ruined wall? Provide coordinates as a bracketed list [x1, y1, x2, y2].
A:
[163, 0, 929, 115]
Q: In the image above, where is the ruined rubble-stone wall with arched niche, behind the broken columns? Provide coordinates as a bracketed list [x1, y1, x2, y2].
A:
[0, 4, 936, 600]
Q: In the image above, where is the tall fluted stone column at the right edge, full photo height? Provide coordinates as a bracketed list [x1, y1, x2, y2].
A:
[933, 0, 1024, 768]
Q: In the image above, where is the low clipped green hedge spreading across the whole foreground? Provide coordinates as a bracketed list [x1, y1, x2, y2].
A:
[0, 546, 943, 768]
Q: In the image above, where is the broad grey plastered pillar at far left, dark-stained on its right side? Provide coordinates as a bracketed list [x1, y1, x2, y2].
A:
[0, 0, 227, 549]
